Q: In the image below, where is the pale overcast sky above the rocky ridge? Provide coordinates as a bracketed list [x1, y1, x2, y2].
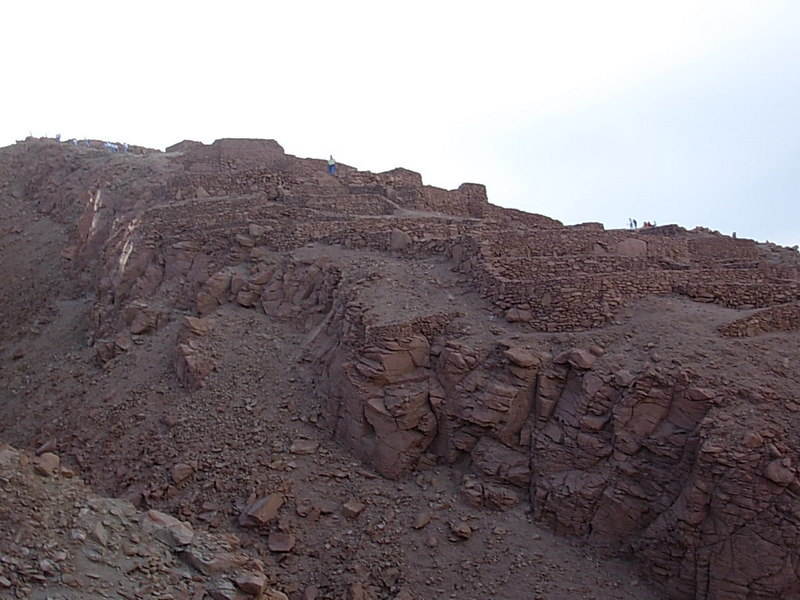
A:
[0, 0, 800, 246]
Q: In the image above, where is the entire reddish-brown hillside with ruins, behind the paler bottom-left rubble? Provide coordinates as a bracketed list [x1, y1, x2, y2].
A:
[0, 139, 800, 599]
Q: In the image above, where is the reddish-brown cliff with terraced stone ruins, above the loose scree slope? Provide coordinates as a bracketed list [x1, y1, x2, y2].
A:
[6, 140, 800, 599]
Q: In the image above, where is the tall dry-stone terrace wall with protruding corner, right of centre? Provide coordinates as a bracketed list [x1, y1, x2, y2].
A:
[450, 232, 800, 331]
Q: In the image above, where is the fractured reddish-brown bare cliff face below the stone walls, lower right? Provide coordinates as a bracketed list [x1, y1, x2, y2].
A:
[300, 288, 798, 598]
